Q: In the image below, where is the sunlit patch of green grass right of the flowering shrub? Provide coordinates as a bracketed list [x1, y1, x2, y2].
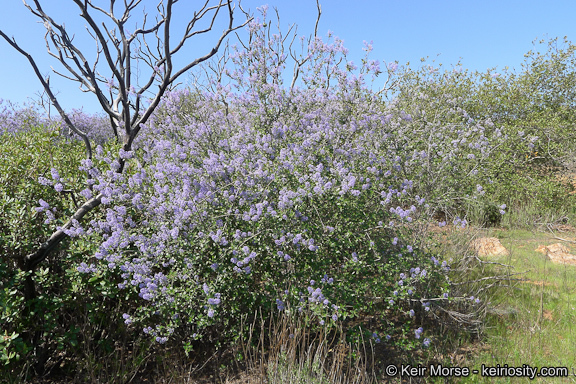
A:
[460, 228, 576, 383]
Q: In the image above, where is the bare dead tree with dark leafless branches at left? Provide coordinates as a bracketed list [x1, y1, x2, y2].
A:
[0, 0, 252, 280]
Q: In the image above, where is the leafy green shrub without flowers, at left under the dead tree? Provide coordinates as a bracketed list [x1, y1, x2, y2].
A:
[0, 126, 148, 379]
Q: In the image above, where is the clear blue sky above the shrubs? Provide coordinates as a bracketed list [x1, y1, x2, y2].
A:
[0, 0, 576, 113]
